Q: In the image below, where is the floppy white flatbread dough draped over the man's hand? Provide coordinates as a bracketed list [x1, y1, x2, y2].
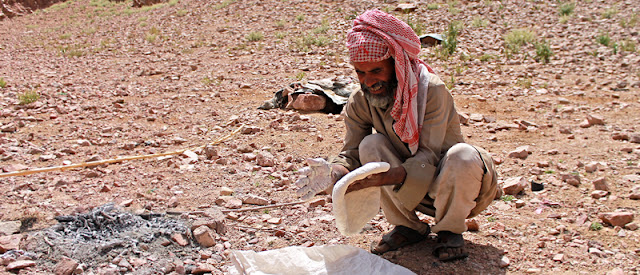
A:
[331, 162, 391, 236]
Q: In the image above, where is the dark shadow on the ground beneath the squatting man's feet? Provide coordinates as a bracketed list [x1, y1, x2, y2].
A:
[383, 238, 507, 274]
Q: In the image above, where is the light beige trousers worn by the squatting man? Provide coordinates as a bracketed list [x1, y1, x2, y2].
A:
[358, 134, 502, 234]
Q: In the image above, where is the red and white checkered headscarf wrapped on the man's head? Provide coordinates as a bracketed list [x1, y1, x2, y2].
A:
[347, 10, 434, 154]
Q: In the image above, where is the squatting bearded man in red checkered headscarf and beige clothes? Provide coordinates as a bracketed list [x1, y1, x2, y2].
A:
[296, 10, 502, 261]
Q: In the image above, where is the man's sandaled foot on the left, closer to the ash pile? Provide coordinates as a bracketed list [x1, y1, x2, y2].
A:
[371, 225, 431, 255]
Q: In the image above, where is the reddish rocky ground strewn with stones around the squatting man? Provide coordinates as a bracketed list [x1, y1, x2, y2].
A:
[0, 0, 640, 274]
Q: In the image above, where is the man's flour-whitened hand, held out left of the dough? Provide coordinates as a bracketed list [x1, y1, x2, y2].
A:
[296, 158, 349, 200]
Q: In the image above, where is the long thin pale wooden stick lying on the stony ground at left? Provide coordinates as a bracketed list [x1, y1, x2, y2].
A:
[0, 124, 244, 178]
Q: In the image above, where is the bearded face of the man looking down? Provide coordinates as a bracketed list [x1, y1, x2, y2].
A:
[353, 58, 398, 108]
